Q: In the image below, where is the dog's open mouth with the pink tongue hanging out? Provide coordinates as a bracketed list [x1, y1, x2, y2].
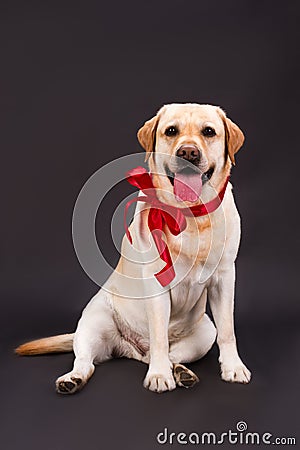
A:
[165, 166, 214, 202]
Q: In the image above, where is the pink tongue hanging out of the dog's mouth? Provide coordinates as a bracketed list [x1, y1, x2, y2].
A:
[174, 172, 202, 202]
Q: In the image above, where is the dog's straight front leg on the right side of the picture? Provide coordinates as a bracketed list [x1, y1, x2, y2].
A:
[208, 264, 251, 383]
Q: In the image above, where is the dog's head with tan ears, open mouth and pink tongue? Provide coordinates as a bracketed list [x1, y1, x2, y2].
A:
[138, 103, 244, 206]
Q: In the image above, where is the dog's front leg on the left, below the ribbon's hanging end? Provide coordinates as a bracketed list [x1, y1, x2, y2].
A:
[144, 292, 176, 392]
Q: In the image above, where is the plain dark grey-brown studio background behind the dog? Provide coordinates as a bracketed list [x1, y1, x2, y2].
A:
[0, 0, 299, 450]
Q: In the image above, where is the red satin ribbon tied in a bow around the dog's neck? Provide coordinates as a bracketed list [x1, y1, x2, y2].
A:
[124, 167, 229, 286]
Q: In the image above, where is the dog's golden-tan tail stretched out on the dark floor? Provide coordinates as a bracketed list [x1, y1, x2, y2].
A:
[15, 333, 74, 356]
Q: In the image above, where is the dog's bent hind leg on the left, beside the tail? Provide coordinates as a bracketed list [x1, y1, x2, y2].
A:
[56, 291, 118, 394]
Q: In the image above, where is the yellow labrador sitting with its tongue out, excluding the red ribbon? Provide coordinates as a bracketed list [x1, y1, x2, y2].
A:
[16, 104, 251, 394]
